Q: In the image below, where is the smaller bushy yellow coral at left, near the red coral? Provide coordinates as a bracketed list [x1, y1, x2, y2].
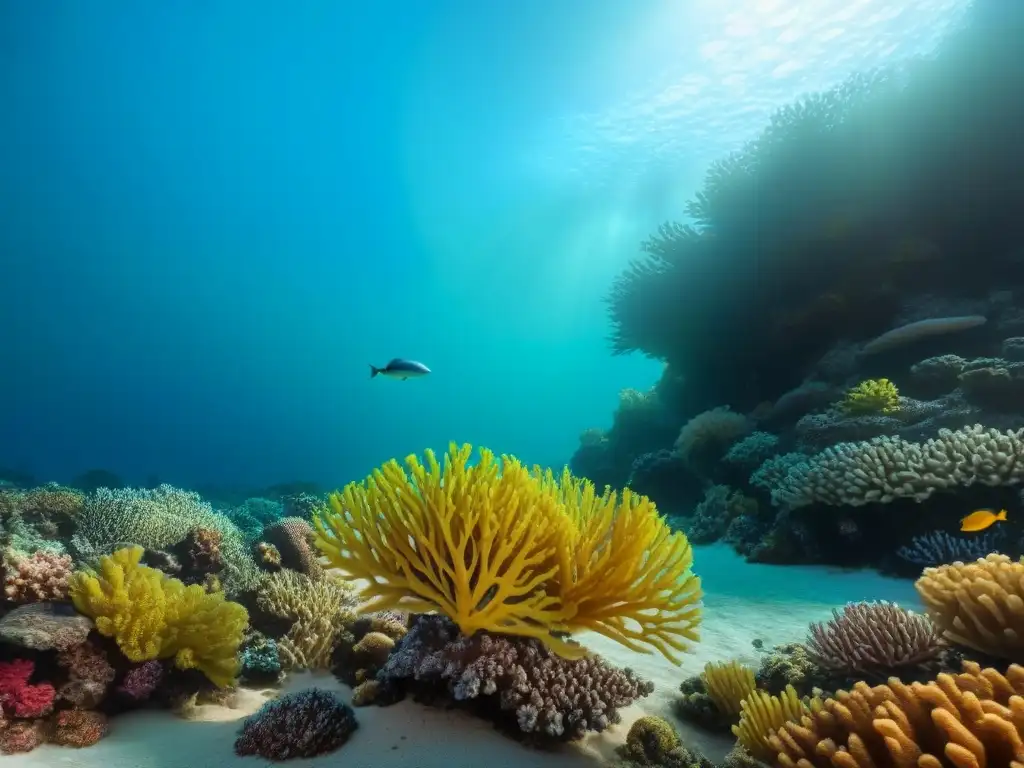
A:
[70, 547, 249, 686]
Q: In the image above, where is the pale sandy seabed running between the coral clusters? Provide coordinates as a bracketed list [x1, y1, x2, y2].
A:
[8, 545, 920, 768]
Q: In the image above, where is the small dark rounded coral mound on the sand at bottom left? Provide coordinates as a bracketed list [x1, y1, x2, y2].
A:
[234, 688, 358, 760]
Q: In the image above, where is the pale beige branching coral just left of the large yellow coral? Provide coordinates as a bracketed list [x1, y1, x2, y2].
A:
[257, 570, 357, 670]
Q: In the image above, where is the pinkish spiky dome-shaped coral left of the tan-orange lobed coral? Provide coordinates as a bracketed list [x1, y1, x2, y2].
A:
[807, 601, 943, 677]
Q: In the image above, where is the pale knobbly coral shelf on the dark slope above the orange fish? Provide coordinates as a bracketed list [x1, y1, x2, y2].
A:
[771, 424, 1024, 509]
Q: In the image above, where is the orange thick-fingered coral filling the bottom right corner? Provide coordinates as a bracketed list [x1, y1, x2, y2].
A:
[768, 662, 1024, 768]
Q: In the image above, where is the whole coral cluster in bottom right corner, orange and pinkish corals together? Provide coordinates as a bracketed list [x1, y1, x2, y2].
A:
[659, 554, 1024, 768]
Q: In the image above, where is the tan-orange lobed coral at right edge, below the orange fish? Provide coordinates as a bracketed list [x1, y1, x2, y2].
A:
[914, 554, 1024, 659]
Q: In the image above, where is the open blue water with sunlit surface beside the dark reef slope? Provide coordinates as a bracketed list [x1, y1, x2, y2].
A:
[0, 0, 963, 486]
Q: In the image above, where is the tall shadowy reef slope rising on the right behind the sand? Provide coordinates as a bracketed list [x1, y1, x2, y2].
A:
[571, 0, 1024, 575]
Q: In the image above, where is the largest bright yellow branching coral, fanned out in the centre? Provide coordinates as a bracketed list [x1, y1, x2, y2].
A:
[313, 444, 700, 660]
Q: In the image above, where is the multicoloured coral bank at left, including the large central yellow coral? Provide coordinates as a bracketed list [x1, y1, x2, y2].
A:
[0, 445, 701, 760]
